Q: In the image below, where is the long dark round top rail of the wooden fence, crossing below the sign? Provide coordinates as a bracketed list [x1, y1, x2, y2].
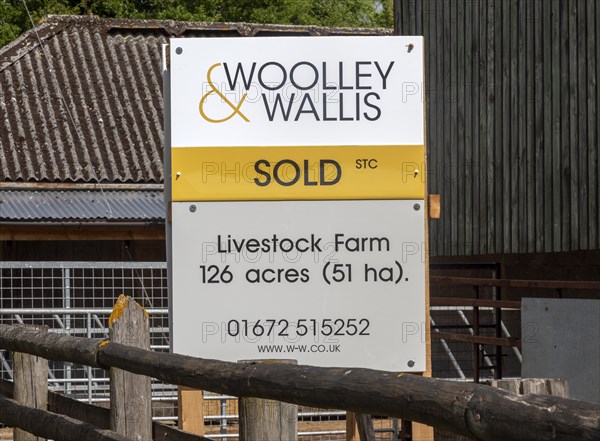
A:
[0, 325, 600, 441]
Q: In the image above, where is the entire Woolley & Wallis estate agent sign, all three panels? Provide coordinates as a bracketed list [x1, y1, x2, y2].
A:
[167, 37, 426, 372]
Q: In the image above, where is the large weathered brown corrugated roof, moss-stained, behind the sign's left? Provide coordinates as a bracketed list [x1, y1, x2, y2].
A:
[0, 16, 389, 183]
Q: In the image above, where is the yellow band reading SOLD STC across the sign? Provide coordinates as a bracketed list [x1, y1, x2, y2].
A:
[172, 145, 425, 201]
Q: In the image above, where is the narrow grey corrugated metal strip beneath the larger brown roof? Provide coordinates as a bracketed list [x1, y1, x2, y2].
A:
[0, 190, 165, 222]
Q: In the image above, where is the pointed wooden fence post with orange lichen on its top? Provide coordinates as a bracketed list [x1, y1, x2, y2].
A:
[108, 295, 152, 441]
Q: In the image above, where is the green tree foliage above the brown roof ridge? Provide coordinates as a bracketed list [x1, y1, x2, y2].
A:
[0, 0, 393, 46]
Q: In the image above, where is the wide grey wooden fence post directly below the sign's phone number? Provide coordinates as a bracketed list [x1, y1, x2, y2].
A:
[239, 360, 298, 441]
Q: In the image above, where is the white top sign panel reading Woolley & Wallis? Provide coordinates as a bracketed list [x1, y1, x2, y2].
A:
[170, 36, 424, 147]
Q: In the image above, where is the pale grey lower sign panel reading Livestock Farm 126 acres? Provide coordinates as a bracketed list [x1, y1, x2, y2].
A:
[172, 200, 425, 371]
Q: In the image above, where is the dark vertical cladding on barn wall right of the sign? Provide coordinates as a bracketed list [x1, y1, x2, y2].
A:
[395, 0, 600, 256]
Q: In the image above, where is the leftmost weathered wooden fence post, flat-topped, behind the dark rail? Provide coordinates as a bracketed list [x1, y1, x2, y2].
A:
[13, 325, 48, 441]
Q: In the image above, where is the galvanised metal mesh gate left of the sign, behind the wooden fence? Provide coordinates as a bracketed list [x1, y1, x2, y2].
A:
[0, 262, 177, 419]
